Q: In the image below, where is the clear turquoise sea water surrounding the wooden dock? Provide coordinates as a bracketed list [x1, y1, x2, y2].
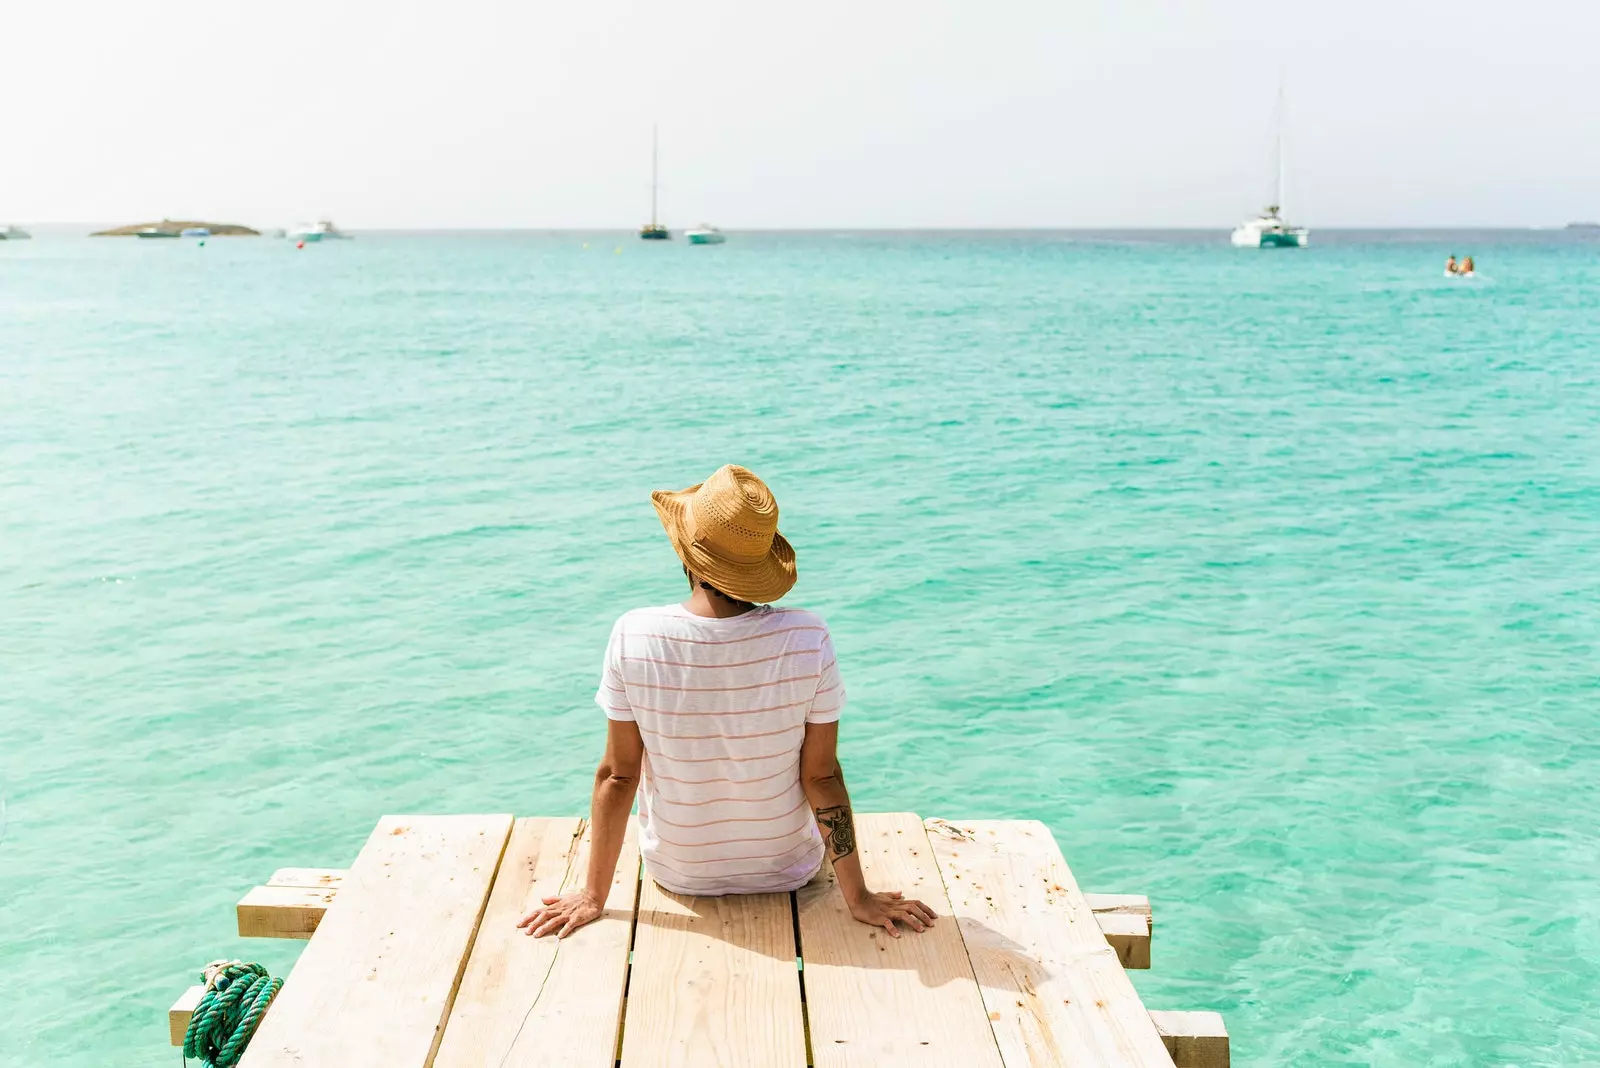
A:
[0, 233, 1600, 1068]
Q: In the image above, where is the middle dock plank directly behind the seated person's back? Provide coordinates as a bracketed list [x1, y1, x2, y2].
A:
[622, 876, 806, 1068]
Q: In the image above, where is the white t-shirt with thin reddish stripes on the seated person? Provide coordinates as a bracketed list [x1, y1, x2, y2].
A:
[595, 604, 845, 895]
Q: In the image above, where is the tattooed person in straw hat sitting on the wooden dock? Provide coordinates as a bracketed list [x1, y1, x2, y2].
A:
[517, 465, 934, 938]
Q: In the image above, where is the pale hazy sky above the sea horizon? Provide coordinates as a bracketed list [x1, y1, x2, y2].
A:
[0, 0, 1600, 229]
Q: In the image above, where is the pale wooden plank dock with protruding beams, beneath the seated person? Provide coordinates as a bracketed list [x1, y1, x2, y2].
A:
[170, 814, 1229, 1068]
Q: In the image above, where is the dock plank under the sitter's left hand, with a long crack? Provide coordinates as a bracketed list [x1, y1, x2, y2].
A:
[434, 819, 638, 1068]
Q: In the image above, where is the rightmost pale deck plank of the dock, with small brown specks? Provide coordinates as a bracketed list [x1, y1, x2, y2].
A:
[930, 820, 1173, 1068]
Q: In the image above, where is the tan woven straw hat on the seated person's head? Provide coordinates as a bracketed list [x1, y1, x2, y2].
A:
[650, 464, 795, 604]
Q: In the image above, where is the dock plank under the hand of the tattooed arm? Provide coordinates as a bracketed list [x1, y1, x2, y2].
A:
[795, 814, 998, 1068]
